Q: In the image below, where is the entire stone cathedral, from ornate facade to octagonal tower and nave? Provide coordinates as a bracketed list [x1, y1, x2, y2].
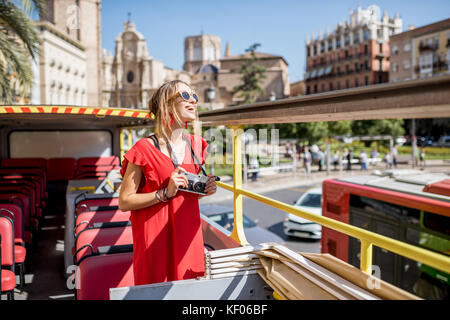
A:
[101, 21, 290, 109]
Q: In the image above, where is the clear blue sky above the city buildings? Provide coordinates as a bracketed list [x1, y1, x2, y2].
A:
[101, 0, 450, 82]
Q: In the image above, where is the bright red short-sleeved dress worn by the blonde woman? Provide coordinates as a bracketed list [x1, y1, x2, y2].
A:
[120, 135, 208, 285]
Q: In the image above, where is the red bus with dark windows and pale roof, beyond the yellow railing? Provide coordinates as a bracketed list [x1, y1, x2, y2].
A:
[321, 170, 450, 299]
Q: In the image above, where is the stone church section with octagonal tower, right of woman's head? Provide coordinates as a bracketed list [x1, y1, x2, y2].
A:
[184, 35, 290, 109]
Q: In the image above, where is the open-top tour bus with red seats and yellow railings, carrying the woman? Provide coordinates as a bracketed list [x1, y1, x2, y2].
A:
[0, 77, 450, 300]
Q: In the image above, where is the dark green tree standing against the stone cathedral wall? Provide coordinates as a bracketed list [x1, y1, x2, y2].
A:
[233, 43, 267, 104]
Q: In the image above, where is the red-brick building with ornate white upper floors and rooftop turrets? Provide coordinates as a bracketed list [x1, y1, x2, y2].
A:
[304, 6, 402, 94]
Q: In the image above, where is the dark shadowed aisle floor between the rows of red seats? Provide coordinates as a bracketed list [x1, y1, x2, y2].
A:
[2, 182, 74, 300]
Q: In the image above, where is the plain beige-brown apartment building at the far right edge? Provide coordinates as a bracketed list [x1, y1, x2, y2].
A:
[390, 19, 450, 82]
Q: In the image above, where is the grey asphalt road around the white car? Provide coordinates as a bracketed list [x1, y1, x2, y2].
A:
[209, 184, 320, 253]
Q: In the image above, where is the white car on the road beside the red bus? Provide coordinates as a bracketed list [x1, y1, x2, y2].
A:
[283, 187, 322, 240]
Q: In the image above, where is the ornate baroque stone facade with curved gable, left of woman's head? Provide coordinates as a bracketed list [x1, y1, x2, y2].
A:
[101, 21, 191, 109]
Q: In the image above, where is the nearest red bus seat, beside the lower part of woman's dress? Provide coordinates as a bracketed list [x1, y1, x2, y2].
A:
[76, 252, 134, 300]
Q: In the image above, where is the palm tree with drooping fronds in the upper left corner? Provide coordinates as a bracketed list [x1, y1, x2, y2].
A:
[0, 0, 45, 104]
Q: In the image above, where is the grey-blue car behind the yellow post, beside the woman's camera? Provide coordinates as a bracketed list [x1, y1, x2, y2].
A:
[200, 204, 284, 245]
